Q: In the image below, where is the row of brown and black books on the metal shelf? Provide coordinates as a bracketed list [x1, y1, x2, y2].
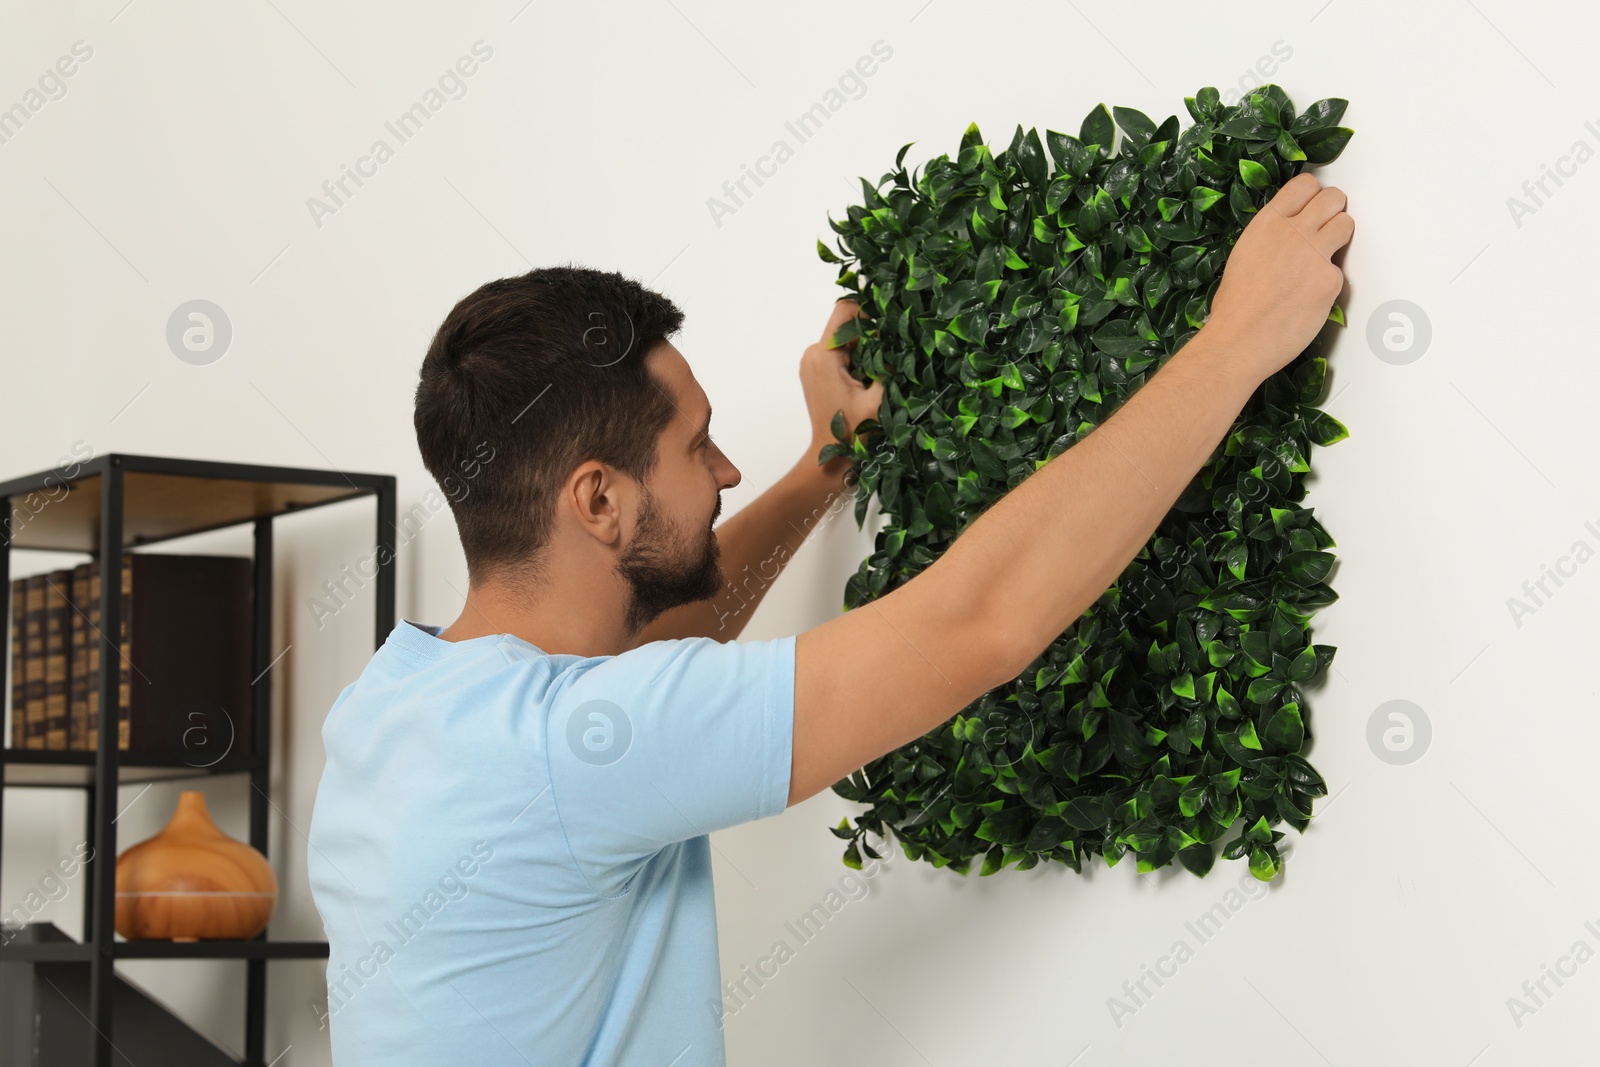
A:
[10, 552, 251, 752]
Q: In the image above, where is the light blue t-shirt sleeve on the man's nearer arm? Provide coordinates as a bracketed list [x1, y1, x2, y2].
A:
[546, 637, 795, 888]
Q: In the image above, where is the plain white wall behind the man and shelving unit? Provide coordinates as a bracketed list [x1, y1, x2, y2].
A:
[0, 0, 1600, 1067]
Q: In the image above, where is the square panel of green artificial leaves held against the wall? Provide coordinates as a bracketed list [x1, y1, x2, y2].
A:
[818, 85, 1352, 880]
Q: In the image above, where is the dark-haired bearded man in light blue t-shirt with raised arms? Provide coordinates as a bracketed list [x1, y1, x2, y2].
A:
[309, 173, 1355, 1067]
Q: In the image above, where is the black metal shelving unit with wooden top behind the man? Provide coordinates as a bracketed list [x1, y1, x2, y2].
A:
[0, 453, 395, 1067]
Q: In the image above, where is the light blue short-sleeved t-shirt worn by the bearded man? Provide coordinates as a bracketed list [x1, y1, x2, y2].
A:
[307, 621, 795, 1067]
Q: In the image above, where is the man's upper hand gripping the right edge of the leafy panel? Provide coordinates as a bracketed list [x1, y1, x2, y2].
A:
[1203, 171, 1355, 381]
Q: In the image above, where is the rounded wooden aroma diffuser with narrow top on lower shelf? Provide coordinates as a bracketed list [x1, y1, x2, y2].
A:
[117, 790, 278, 941]
